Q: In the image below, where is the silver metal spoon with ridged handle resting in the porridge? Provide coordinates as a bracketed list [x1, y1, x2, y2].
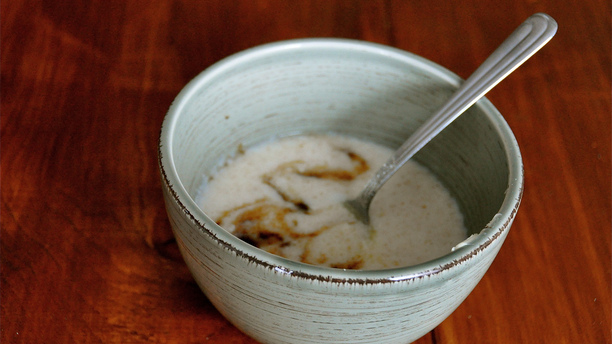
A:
[344, 13, 557, 224]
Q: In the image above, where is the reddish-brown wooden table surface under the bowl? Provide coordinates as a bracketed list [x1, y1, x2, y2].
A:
[0, 0, 612, 344]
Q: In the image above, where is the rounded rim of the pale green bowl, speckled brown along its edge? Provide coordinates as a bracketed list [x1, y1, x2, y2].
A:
[158, 39, 524, 284]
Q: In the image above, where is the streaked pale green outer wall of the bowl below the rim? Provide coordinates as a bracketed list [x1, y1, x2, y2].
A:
[164, 177, 510, 343]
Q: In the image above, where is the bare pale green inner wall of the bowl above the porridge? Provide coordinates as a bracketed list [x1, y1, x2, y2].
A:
[164, 41, 520, 249]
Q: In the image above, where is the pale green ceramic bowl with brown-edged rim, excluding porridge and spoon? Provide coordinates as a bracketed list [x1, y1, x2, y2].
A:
[159, 39, 523, 343]
